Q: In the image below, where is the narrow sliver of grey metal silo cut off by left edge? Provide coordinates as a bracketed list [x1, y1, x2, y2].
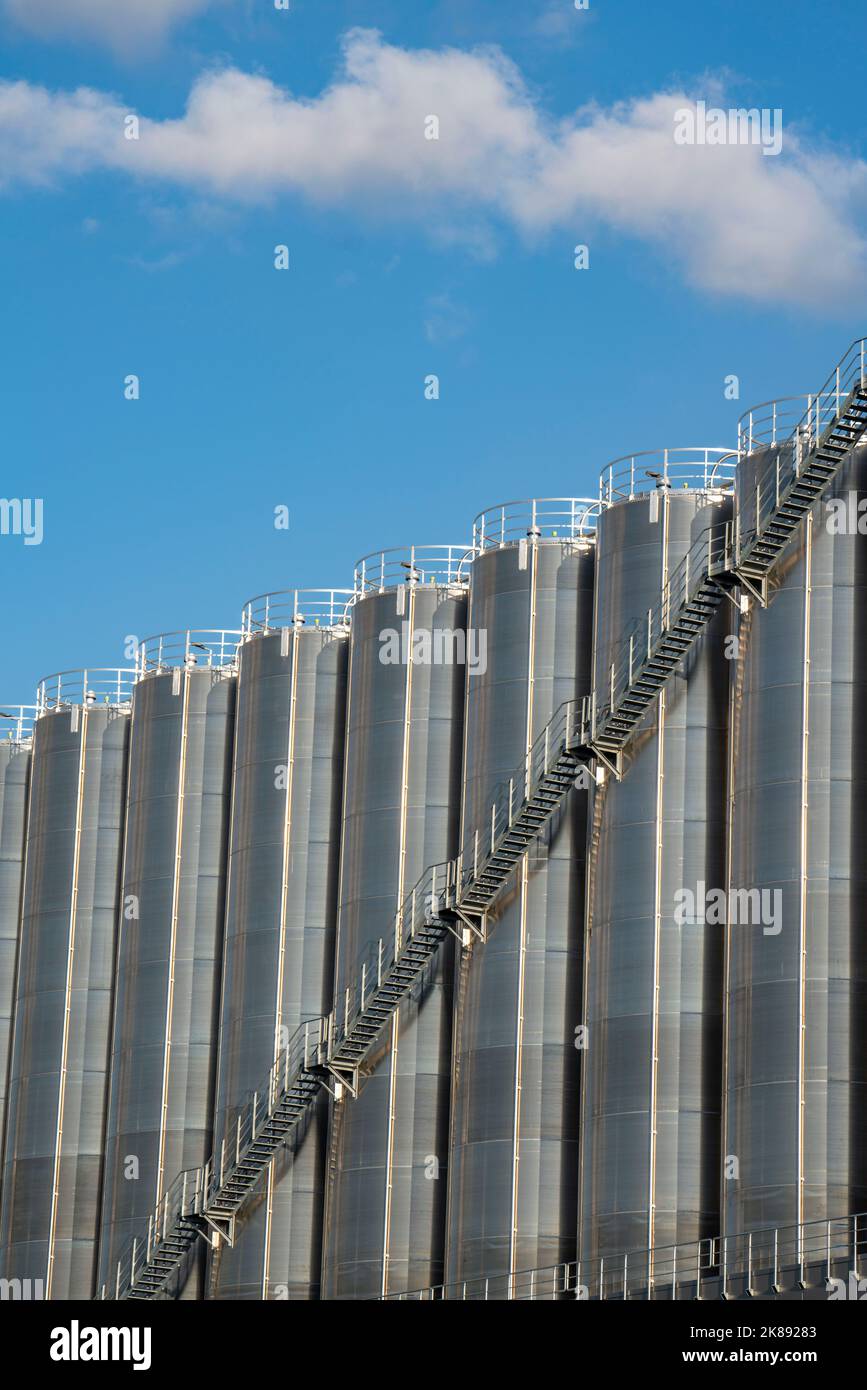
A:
[0, 705, 36, 1194]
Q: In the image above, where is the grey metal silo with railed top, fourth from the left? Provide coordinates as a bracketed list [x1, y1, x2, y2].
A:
[208, 589, 352, 1300]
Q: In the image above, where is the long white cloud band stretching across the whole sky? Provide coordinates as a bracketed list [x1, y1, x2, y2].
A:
[0, 31, 867, 306]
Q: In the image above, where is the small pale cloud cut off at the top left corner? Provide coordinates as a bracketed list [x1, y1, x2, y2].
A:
[1, 0, 213, 51]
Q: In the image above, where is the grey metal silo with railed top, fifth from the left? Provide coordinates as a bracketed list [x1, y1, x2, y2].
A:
[324, 546, 467, 1298]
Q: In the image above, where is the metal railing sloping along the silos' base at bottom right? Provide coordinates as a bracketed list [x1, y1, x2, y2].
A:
[386, 1213, 867, 1302]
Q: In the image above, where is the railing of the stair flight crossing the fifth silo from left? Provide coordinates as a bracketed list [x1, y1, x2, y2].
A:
[328, 862, 457, 1056]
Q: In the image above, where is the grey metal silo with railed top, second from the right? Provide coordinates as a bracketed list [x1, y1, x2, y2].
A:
[579, 449, 735, 1284]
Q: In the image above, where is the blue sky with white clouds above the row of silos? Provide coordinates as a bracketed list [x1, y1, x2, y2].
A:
[0, 0, 867, 702]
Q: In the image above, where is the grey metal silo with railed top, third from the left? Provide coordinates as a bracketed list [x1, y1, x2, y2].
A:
[99, 631, 240, 1298]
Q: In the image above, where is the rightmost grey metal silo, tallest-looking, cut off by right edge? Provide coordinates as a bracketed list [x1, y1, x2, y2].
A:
[723, 396, 867, 1245]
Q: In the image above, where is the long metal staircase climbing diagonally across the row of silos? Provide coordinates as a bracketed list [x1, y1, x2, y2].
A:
[99, 330, 867, 1300]
